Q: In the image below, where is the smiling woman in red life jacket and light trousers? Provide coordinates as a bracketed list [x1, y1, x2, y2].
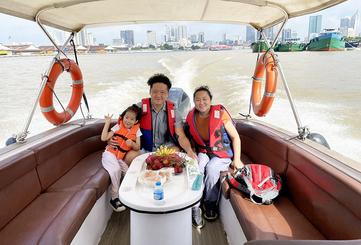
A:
[186, 86, 243, 228]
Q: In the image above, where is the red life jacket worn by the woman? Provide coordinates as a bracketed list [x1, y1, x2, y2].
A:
[186, 105, 233, 158]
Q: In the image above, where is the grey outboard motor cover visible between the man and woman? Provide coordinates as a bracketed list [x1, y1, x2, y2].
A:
[168, 88, 191, 121]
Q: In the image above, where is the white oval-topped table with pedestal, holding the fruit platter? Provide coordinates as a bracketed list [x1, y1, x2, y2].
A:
[119, 153, 203, 245]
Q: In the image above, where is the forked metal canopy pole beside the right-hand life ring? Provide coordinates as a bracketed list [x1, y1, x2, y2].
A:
[261, 17, 310, 140]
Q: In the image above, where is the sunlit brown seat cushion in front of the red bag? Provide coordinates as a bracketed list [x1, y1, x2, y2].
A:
[230, 189, 325, 240]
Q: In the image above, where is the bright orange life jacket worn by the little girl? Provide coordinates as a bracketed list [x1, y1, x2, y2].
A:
[106, 120, 139, 160]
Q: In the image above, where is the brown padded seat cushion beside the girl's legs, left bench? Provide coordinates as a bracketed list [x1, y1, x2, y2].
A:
[46, 151, 110, 198]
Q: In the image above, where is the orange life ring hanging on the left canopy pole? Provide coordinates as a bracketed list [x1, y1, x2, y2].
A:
[39, 59, 83, 125]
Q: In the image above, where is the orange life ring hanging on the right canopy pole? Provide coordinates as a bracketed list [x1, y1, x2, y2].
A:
[251, 53, 277, 117]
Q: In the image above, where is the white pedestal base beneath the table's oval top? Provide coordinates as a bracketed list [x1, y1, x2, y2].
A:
[130, 208, 192, 245]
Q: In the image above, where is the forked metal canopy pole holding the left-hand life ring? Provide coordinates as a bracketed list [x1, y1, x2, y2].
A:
[15, 10, 74, 143]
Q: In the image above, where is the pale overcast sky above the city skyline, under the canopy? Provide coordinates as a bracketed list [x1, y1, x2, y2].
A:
[0, 0, 361, 45]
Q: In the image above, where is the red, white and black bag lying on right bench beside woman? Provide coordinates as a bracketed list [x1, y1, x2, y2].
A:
[227, 164, 282, 204]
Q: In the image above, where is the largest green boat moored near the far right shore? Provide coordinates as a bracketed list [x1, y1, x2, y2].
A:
[307, 29, 345, 51]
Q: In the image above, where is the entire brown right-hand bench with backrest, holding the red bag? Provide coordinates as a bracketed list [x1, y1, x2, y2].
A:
[222, 121, 361, 244]
